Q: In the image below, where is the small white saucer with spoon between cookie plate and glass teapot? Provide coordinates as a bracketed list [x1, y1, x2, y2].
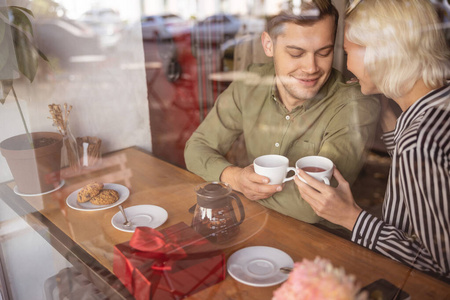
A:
[111, 205, 168, 232]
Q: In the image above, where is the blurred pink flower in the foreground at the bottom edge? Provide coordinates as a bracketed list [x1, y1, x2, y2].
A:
[272, 257, 368, 300]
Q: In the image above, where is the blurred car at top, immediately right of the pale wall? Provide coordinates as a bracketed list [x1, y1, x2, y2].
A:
[141, 14, 190, 40]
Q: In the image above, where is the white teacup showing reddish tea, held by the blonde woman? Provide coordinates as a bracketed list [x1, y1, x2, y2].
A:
[295, 155, 334, 185]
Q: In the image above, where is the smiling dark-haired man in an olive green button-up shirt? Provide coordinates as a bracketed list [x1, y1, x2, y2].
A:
[185, 0, 380, 223]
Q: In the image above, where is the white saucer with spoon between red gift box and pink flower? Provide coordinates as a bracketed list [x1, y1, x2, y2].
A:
[227, 246, 294, 287]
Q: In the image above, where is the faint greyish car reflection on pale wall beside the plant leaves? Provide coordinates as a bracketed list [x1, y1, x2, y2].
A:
[34, 18, 101, 67]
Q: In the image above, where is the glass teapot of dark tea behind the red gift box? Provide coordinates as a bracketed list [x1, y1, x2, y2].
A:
[191, 182, 245, 243]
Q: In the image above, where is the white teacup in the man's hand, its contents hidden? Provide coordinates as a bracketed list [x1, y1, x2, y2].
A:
[253, 154, 297, 184]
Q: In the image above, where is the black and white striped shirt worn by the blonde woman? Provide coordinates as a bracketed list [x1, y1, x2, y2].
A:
[352, 85, 450, 282]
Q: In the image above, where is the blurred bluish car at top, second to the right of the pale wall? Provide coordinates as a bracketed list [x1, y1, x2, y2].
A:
[192, 14, 242, 44]
